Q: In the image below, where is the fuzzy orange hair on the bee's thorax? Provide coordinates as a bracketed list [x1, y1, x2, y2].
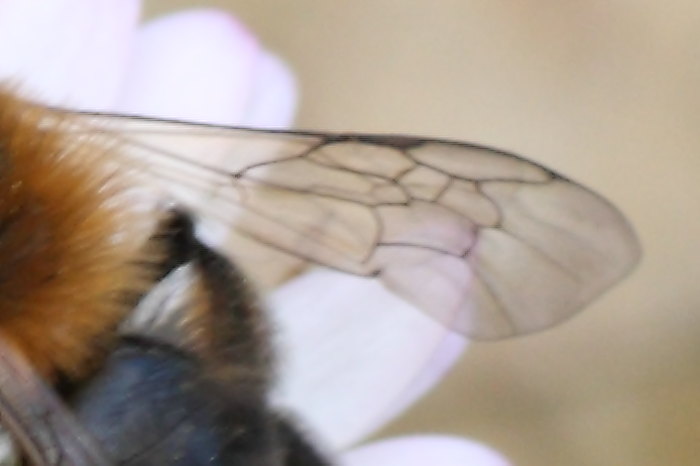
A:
[0, 89, 160, 377]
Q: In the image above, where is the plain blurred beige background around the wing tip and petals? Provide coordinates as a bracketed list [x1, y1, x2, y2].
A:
[146, 0, 700, 466]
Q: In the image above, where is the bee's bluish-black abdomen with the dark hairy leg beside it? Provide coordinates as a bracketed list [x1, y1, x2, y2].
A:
[74, 214, 329, 466]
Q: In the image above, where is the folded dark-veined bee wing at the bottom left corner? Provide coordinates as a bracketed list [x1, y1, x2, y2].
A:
[0, 339, 112, 466]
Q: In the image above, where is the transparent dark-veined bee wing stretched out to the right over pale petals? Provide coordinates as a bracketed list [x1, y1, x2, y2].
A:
[67, 114, 640, 339]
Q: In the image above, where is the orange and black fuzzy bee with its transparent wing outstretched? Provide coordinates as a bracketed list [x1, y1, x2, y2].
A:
[0, 88, 640, 465]
